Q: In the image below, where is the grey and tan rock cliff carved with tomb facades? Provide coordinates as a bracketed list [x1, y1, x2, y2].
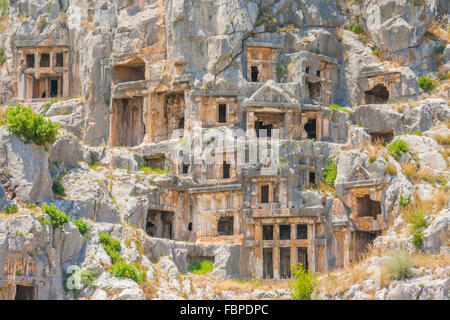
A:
[0, 0, 450, 299]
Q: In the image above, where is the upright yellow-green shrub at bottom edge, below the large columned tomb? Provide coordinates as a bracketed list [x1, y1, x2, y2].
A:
[289, 263, 318, 300]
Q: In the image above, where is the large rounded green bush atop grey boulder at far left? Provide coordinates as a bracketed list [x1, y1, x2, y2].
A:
[6, 105, 59, 145]
